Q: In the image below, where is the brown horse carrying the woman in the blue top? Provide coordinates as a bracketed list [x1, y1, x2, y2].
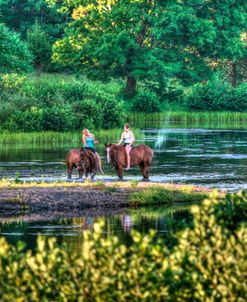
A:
[66, 148, 104, 179]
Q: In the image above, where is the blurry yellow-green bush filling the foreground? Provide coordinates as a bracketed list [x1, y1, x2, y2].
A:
[0, 194, 247, 301]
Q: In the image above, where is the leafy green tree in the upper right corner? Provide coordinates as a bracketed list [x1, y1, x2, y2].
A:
[159, 0, 247, 87]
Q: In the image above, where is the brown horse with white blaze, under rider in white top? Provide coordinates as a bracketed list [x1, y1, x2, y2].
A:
[105, 144, 154, 180]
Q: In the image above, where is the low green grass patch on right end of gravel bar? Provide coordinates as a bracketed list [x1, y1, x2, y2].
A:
[129, 187, 208, 205]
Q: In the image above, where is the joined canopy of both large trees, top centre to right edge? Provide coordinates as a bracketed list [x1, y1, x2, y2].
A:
[49, 0, 247, 94]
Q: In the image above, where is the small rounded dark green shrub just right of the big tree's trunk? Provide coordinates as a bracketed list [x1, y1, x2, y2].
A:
[131, 90, 161, 113]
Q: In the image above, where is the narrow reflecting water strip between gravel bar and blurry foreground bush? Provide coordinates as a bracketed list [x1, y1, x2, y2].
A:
[0, 207, 191, 250]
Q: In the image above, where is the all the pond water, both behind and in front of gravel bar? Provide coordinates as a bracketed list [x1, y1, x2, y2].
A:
[0, 127, 247, 248]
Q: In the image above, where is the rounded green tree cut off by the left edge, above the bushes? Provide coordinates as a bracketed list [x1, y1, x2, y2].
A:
[0, 23, 33, 73]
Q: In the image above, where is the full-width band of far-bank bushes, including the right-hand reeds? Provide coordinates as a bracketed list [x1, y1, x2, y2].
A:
[0, 74, 247, 131]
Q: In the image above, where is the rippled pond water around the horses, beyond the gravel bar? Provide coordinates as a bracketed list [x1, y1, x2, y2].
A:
[0, 128, 247, 191]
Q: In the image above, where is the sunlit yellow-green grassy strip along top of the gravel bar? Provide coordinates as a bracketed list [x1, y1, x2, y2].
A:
[0, 179, 210, 206]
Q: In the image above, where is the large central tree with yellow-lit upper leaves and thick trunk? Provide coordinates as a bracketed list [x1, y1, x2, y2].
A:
[50, 0, 166, 95]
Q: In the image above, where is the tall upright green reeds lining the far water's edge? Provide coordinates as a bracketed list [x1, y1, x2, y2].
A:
[0, 111, 247, 144]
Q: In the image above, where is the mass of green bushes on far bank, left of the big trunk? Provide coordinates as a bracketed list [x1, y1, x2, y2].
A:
[0, 75, 125, 131]
